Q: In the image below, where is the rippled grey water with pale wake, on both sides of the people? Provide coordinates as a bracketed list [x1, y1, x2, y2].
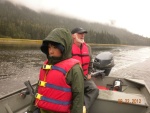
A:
[0, 46, 150, 97]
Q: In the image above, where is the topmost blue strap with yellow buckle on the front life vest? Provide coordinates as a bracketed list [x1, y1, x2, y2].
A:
[42, 65, 67, 75]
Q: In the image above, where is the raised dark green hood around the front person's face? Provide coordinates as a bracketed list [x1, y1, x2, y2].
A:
[41, 28, 72, 64]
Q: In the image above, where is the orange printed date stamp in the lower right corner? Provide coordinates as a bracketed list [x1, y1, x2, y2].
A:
[118, 98, 142, 104]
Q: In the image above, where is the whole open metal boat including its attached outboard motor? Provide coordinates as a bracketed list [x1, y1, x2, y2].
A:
[0, 52, 150, 113]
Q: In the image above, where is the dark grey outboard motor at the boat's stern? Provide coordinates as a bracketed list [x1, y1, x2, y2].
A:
[93, 52, 114, 76]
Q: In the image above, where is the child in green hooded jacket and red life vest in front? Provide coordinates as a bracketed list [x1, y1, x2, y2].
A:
[27, 28, 84, 113]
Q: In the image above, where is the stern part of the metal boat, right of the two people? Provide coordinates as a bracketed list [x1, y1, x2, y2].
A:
[90, 77, 150, 113]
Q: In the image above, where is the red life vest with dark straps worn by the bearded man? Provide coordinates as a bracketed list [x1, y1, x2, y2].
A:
[72, 43, 90, 75]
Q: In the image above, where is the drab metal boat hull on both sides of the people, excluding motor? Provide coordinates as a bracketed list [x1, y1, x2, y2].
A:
[0, 76, 150, 113]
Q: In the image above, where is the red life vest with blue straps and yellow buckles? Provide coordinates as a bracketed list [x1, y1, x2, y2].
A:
[35, 58, 79, 113]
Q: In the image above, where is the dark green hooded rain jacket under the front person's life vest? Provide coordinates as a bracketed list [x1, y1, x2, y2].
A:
[28, 28, 84, 113]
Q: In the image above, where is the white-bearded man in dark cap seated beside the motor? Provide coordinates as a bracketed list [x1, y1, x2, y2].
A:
[71, 27, 99, 113]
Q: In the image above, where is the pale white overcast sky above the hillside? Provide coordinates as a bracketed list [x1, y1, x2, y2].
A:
[9, 0, 150, 38]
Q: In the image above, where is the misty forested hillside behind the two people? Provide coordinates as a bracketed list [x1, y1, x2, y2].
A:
[0, 1, 150, 46]
